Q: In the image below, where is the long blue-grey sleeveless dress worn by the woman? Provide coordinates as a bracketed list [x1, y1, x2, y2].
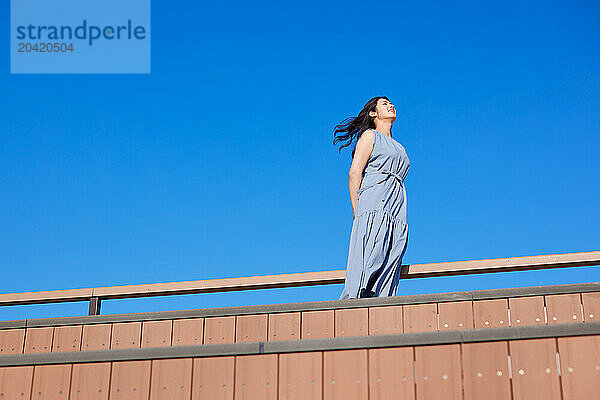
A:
[340, 129, 410, 300]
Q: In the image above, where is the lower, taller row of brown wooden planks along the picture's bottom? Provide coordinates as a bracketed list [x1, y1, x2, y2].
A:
[0, 335, 600, 400]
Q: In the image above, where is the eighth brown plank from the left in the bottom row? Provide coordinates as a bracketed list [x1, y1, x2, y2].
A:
[278, 352, 323, 400]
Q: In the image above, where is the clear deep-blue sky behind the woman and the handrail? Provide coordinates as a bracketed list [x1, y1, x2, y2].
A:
[0, 1, 600, 320]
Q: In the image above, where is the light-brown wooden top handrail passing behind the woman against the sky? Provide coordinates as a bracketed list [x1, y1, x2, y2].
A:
[0, 251, 600, 306]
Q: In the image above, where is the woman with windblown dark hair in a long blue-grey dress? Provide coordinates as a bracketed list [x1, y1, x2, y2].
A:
[333, 96, 410, 300]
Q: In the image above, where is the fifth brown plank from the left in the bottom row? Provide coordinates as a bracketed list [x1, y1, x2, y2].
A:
[150, 358, 193, 400]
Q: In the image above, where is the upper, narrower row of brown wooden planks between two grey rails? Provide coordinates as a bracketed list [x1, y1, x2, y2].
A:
[0, 292, 600, 354]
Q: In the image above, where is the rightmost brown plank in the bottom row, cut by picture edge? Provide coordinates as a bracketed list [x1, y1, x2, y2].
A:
[558, 336, 600, 400]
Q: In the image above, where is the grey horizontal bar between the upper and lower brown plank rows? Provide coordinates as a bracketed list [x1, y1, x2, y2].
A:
[0, 322, 600, 367]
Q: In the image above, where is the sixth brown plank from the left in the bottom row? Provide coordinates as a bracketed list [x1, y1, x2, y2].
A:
[192, 356, 235, 400]
